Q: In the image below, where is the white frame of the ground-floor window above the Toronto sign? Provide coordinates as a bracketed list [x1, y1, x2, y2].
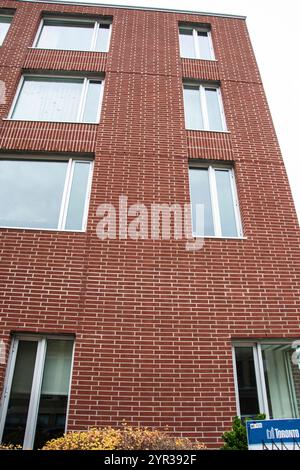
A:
[232, 339, 295, 419]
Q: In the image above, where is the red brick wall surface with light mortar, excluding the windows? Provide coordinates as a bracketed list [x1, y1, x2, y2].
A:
[0, 0, 300, 446]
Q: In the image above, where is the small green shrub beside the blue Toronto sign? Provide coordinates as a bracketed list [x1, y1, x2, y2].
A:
[221, 414, 266, 450]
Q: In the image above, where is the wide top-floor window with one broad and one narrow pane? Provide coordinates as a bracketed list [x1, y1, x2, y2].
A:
[34, 18, 111, 52]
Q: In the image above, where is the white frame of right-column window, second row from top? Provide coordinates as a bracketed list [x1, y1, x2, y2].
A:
[183, 81, 228, 132]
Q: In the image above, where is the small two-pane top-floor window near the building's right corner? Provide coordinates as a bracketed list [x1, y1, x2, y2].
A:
[179, 26, 215, 60]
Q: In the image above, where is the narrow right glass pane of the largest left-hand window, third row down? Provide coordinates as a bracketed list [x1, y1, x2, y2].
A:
[65, 162, 90, 230]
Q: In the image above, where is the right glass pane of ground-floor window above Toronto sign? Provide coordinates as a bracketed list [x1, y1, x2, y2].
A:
[262, 344, 300, 419]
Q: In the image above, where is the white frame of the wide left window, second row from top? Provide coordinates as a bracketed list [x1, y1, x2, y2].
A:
[6, 73, 104, 125]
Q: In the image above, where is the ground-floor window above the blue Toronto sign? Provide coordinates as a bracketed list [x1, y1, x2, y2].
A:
[234, 341, 300, 419]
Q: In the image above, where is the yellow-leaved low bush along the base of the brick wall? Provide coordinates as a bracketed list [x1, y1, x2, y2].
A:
[42, 422, 205, 450]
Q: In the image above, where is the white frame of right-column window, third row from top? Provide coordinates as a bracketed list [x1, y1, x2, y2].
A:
[189, 161, 244, 239]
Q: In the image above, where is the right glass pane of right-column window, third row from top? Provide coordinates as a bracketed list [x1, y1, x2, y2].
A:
[215, 170, 238, 237]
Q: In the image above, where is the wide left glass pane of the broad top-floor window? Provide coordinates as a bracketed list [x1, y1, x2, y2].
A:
[36, 20, 94, 51]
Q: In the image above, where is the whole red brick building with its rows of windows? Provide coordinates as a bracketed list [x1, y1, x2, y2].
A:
[0, 0, 300, 448]
